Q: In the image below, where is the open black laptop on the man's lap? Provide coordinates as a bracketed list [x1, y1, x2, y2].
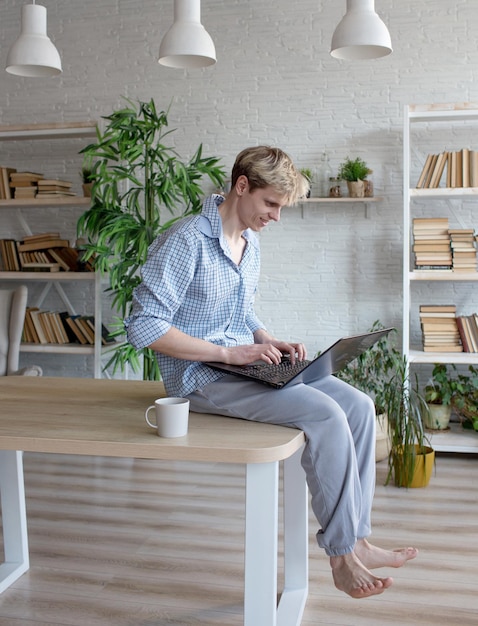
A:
[205, 328, 395, 389]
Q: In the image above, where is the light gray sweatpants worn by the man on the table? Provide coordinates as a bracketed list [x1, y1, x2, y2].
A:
[188, 376, 375, 556]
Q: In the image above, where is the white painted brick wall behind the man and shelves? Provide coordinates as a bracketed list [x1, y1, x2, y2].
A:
[0, 0, 478, 376]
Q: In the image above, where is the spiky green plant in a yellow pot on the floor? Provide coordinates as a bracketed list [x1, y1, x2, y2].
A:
[385, 357, 435, 487]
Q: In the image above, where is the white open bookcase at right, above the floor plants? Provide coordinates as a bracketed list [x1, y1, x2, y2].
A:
[403, 103, 478, 452]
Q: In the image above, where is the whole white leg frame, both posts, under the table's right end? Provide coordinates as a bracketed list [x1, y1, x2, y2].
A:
[244, 449, 308, 626]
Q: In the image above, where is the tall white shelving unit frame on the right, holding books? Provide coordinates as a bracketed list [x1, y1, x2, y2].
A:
[403, 103, 478, 453]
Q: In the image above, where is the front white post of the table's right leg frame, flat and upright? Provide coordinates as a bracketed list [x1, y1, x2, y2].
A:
[244, 462, 279, 626]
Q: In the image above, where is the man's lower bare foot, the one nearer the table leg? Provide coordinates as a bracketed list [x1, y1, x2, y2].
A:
[330, 552, 393, 598]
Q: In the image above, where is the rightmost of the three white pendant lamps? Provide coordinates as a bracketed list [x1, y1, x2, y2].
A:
[330, 0, 392, 61]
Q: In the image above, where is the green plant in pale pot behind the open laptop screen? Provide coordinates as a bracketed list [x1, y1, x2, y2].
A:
[337, 320, 401, 461]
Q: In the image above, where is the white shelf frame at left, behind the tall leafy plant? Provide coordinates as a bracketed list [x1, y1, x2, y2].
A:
[0, 122, 107, 378]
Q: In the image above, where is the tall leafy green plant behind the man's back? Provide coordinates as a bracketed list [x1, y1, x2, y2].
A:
[77, 99, 225, 380]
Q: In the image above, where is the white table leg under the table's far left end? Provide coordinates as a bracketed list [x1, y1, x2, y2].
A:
[0, 450, 30, 593]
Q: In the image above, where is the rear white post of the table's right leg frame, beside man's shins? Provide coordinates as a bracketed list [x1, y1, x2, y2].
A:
[277, 449, 309, 626]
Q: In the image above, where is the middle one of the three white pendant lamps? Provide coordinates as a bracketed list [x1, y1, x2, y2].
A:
[158, 0, 216, 69]
